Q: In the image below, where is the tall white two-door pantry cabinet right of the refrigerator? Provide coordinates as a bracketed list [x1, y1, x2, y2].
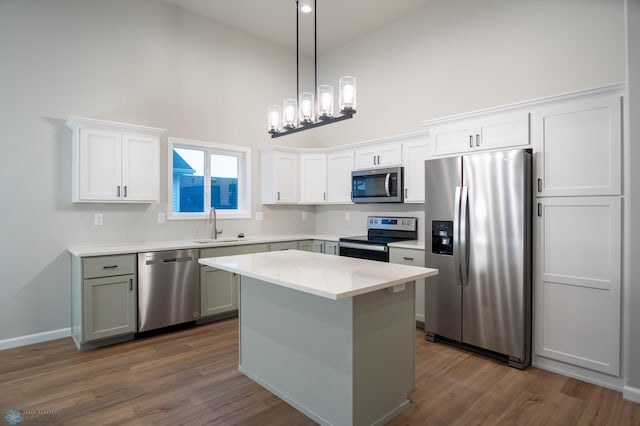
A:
[531, 90, 623, 376]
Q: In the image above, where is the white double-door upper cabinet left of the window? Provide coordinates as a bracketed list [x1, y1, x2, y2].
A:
[67, 117, 165, 202]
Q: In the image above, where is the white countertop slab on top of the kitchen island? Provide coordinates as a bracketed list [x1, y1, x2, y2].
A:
[199, 250, 438, 300]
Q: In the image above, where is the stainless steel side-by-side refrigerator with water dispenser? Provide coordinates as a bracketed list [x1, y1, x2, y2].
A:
[425, 150, 531, 368]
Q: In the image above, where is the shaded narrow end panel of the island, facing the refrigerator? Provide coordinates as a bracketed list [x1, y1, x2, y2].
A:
[353, 282, 416, 425]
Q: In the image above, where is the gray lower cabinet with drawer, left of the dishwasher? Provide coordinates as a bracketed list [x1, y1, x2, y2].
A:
[71, 254, 137, 349]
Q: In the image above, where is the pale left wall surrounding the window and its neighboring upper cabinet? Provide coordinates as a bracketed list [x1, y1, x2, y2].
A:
[0, 0, 315, 341]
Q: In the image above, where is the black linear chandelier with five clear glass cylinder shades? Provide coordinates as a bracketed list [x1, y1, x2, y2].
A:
[267, 0, 356, 138]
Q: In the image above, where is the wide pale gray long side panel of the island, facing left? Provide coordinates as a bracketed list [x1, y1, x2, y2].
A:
[239, 276, 353, 425]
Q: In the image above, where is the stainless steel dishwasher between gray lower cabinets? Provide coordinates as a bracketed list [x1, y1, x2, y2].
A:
[138, 249, 200, 332]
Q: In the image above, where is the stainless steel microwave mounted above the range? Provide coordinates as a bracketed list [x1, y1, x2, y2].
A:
[351, 167, 404, 203]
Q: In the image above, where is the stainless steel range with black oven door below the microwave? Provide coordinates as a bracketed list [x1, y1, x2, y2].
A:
[338, 216, 418, 262]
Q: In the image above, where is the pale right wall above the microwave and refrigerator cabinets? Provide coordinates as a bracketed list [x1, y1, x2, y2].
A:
[317, 0, 626, 146]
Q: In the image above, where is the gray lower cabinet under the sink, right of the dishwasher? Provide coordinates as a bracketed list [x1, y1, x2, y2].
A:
[200, 244, 270, 318]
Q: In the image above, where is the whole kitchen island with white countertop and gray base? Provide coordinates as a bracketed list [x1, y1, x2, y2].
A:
[200, 250, 438, 425]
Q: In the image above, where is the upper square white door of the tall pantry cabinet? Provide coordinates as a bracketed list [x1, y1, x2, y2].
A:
[531, 95, 622, 196]
